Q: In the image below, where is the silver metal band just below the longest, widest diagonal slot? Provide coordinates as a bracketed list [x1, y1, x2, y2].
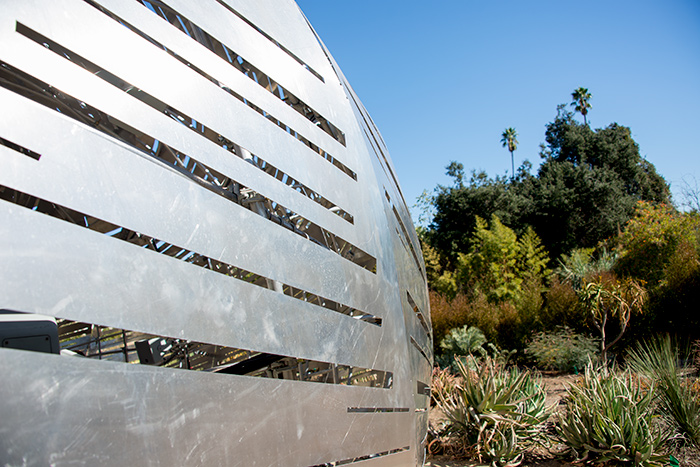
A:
[0, 89, 371, 288]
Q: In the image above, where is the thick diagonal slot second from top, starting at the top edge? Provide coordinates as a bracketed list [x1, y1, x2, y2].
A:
[137, 0, 345, 146]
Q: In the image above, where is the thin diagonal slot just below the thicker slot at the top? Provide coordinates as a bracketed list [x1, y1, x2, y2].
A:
[83, 0, 357, 180]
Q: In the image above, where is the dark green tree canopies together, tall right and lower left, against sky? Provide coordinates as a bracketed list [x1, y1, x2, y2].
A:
[430, 105, 670, 260]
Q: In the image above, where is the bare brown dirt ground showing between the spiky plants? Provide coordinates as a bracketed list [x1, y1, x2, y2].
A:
[425, 375, 700, 467]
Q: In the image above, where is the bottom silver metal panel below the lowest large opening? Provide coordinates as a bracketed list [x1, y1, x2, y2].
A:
[0, 349, 410, 466]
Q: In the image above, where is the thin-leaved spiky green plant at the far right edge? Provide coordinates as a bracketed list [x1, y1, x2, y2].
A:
[630, 336, 700, 448]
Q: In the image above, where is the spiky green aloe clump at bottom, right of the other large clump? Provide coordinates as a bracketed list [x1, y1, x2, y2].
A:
[556, 365, 668, 466]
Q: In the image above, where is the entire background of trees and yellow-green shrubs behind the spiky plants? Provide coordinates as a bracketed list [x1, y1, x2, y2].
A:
[418, 99, 700, 359]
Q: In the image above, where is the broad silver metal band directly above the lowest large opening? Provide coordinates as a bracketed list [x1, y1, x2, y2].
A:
[0, 203, 386, 371]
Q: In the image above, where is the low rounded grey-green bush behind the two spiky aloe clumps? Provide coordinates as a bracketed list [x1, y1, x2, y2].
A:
[525, 326, 600, 373]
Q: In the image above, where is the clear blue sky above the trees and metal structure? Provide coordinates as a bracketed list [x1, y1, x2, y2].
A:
[297, 0, 700, 219]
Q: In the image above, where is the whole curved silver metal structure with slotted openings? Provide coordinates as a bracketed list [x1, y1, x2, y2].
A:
[0, 0, 432, 467]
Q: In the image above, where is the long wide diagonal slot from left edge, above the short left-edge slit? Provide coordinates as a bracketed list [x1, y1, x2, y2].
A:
[0, 61, 377, 273]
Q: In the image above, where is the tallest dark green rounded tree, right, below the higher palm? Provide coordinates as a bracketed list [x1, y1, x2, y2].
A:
[523, 106, 670, 256]
